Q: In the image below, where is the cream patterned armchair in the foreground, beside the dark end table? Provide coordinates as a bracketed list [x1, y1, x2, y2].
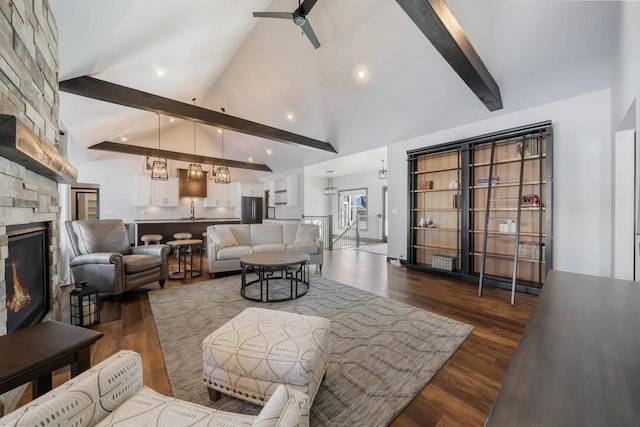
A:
[0, 350, 308, 427]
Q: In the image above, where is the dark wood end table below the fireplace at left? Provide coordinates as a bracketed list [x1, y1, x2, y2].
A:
[0, 321, 103, 399]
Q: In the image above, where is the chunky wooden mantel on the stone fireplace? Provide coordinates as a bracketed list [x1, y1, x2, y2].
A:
[0, 114, 78, 184]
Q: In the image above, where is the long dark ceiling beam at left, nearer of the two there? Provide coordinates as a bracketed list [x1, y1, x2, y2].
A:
[59, 76, 337, 153]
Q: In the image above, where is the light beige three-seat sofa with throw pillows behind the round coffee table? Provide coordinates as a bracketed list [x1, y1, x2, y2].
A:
[207, 224, 324, 278]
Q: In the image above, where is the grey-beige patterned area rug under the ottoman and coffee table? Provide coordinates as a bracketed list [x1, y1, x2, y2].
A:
[149, 276, 473, 426]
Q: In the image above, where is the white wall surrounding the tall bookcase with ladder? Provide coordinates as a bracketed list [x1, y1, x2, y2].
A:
[388, 90, 612, 276]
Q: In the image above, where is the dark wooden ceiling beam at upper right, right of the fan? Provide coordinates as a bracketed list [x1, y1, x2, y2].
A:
[396, 0, 502, 111]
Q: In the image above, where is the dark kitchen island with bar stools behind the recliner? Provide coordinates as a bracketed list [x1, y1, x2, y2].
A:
[134, 217, 240, 246]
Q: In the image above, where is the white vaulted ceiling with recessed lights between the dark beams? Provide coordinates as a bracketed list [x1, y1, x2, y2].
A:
[50, 0, 619, 175]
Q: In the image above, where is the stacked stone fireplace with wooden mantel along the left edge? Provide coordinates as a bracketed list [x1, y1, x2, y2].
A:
[0, 0, 77, 413]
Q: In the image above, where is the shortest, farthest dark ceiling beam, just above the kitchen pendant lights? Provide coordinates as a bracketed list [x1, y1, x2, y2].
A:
[89, 141, 273, 172]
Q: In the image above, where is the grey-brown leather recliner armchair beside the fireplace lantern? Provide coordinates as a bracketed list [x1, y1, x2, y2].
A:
[65, 219, 169, 295]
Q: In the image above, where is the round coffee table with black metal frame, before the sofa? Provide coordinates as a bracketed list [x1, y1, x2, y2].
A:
[240, 251, 309, 302]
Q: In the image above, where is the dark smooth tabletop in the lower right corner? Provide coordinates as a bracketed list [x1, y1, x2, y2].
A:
[486, 271, 640, 427]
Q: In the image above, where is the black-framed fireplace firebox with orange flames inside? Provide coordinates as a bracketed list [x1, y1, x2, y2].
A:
[5, 223, 50, 332]
